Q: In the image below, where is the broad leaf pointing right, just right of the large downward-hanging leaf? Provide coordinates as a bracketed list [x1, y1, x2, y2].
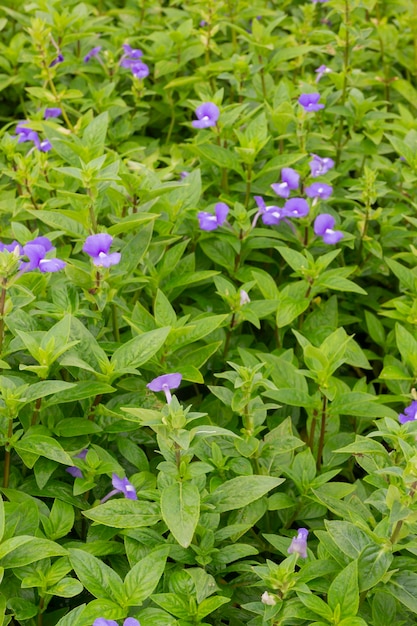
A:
[206, 475, 284, 513]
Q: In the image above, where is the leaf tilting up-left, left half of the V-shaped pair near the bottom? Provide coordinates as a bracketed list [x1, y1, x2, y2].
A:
[69, 548, 126, 606]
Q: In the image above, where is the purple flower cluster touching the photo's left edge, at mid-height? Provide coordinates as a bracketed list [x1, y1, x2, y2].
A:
[0, 237, 66, 274]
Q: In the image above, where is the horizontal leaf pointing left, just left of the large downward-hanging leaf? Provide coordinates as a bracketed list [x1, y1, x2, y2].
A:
[83, 498, 161, 528]
